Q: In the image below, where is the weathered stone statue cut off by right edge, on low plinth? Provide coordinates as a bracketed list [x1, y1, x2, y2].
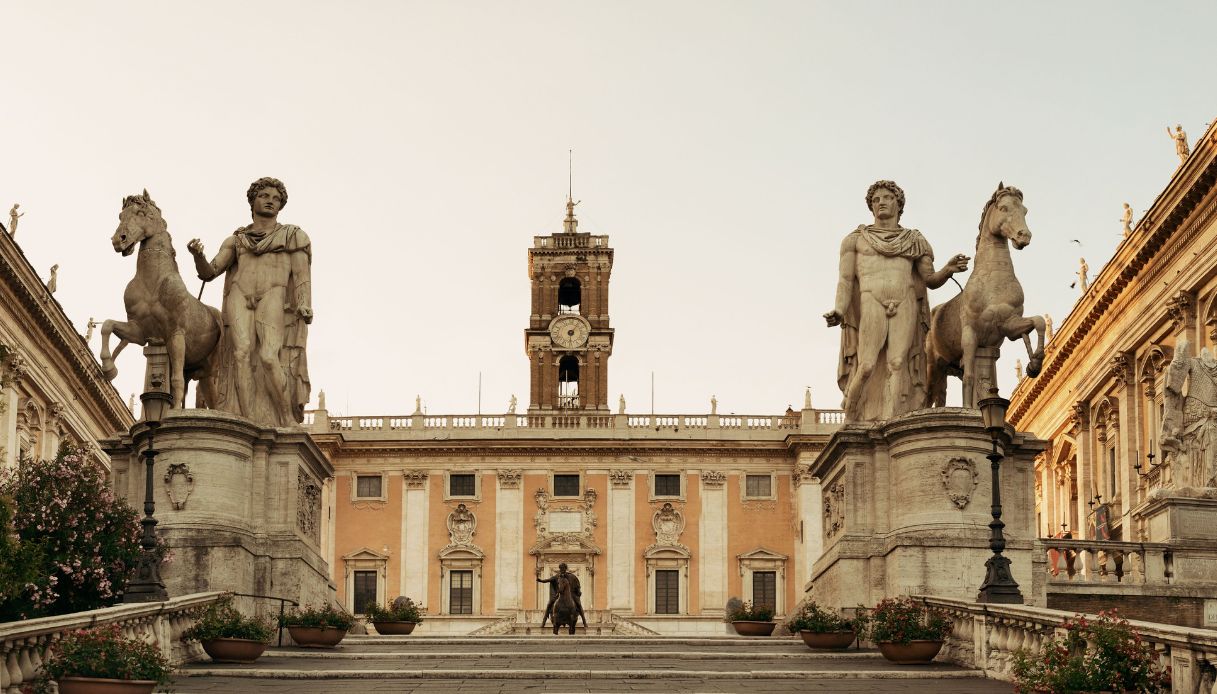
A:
[1161, 337, 1217, 488]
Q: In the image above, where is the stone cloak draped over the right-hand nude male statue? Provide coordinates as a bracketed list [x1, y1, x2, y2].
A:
[837, 224, 933, 421]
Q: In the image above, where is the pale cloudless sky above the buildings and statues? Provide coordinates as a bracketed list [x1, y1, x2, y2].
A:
[0, 0, 1217, 415]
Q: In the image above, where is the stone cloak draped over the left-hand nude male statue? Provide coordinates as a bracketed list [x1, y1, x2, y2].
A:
[206, 224, 313, 426]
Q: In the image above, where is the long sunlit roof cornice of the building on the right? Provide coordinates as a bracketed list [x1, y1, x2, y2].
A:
[1008, 128, 1217, 426]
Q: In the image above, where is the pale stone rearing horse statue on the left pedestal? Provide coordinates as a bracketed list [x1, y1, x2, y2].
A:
[101, 190, 223, 408]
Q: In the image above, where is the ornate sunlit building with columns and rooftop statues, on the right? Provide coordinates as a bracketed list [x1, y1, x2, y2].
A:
[1009, 121, 1217, 626]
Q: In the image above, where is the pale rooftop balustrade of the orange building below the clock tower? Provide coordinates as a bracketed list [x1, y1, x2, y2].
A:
[304, 409, 845, 441]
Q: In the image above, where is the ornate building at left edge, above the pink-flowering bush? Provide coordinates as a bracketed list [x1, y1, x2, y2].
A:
[0, 221, 134, 466]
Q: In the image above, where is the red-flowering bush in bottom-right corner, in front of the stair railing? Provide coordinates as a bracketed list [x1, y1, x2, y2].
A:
[1014, 610, 1171, 693]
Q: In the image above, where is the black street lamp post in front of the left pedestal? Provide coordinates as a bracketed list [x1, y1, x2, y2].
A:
[123, 341, 173, 603]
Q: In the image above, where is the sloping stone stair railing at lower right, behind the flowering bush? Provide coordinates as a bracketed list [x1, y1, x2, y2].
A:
[920, 597, 1217, 694]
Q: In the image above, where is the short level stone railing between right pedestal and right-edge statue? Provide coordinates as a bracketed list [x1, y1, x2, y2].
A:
[1038, 537, 1172, 586]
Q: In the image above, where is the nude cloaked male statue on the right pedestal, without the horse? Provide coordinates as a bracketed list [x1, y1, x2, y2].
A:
[824, 180, 970, 421]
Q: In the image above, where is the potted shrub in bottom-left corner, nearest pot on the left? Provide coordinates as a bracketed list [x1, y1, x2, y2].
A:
[34, 625, 173, 694]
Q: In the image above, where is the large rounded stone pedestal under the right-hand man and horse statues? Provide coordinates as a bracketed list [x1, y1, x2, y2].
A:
[808, 408, 1044, 608]
